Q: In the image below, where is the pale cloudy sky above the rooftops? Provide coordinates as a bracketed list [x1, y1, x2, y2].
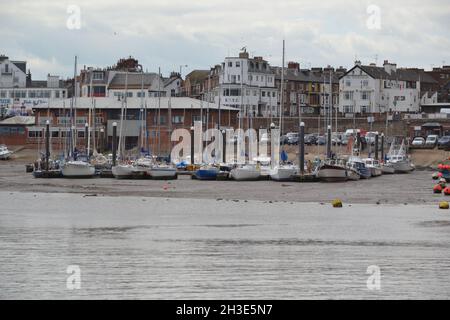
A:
[0, 0, 450, 80]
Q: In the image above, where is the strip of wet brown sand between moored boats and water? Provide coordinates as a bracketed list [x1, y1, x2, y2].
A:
[0, 161, 442, 204]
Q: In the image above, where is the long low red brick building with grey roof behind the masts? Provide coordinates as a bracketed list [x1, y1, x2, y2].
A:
[27, 97, 238, 154]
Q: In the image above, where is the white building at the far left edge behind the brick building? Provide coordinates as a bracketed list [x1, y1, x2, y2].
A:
[0, 55, 67, 114]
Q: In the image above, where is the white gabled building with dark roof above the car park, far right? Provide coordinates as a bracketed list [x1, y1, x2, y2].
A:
[339, 61, 420, 113]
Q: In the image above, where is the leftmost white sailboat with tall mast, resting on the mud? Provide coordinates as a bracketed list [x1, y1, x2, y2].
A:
[61, 56, 95, 178]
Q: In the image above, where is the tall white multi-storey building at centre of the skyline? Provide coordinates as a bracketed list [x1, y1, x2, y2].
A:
[215, 51, 278, 116]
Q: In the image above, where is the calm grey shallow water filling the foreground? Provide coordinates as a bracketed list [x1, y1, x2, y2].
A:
[0, 192, 450, 299]
